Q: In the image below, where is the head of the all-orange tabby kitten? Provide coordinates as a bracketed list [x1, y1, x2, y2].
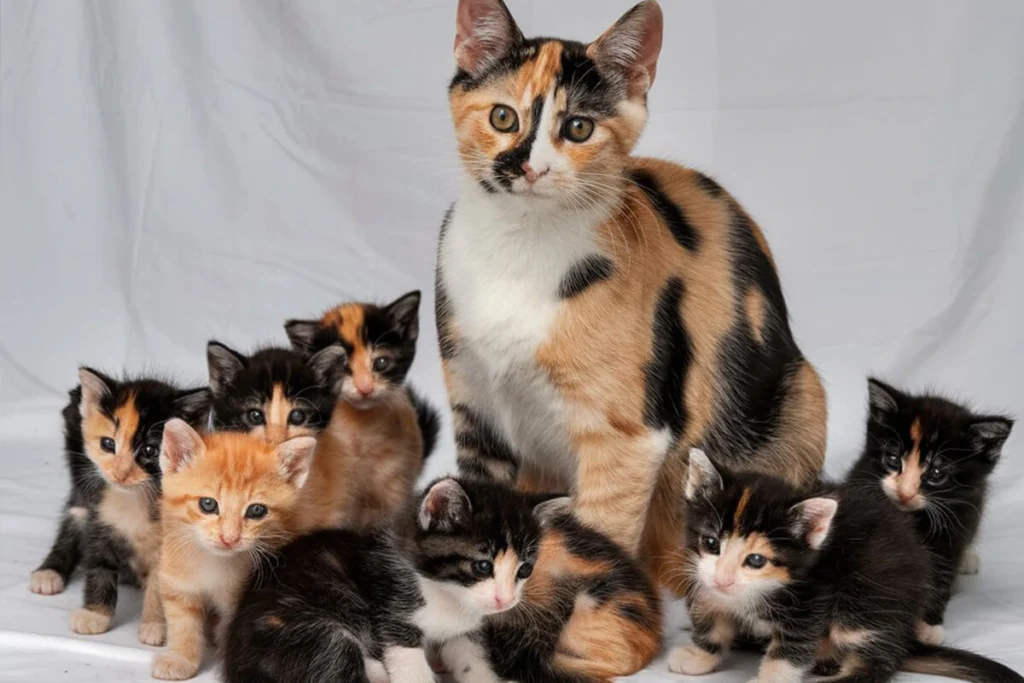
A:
[160, 420, 316, 555]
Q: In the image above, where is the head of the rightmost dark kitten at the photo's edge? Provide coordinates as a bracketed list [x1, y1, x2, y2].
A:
[854, 378, 1014, 510]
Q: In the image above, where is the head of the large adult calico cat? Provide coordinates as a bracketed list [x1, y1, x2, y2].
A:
[449, 0, 663, 207]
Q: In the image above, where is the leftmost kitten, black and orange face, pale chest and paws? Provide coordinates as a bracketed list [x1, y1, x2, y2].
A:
[29, 368, 210, 644]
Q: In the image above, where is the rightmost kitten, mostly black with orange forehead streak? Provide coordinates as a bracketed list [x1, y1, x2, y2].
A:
[849, 378, 1014, 645]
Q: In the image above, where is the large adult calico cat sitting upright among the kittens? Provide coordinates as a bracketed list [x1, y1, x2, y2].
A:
[435, 0, 826, 593]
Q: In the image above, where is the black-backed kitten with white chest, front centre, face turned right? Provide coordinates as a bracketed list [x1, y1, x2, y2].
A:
[224, 478, 540, 683]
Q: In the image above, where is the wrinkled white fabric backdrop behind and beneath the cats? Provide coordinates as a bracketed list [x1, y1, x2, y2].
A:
[0, 0, 1024, 681]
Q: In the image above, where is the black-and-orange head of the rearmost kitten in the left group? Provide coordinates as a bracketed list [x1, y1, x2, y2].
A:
[285, 292, 420, 408]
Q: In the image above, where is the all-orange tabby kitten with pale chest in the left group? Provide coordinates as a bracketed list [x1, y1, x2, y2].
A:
[153, 420, 316, 680]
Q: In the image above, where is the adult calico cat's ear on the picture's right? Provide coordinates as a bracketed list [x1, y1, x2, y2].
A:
[587, 0, 664, 96]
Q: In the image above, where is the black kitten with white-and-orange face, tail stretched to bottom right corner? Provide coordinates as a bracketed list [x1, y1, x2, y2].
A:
[669, 449, 1024, 683]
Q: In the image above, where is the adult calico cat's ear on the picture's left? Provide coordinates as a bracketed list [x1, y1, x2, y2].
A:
[454, 0, 523, 74]
